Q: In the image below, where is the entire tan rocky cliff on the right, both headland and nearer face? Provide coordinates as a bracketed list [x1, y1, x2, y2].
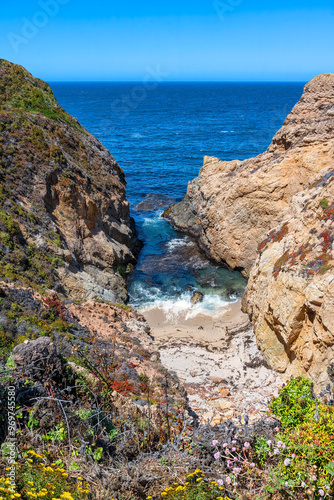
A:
[166, 74, 334, 386]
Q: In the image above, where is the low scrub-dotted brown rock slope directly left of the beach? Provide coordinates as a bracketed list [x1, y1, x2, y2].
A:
[0, 281, 188, 415]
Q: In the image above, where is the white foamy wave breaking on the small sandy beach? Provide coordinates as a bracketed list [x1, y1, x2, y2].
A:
[141, 293, 229, 323]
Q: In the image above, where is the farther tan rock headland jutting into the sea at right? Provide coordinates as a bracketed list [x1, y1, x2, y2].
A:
[165, 73, 334, 276]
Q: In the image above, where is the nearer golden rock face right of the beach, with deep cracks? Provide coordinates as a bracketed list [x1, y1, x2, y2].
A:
[243, 178, 334, 387]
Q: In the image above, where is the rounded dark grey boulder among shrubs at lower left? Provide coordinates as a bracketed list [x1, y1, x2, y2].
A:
[13, 337, 62, 379]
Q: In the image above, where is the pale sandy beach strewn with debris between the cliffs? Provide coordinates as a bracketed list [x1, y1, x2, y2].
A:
[141, 301, 283, 425]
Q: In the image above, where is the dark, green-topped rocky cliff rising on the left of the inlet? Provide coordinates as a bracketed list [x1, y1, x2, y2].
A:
[0, 60, 140, 302]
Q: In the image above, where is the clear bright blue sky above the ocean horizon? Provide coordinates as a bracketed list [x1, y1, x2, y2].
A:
[0, 0, 334, 82]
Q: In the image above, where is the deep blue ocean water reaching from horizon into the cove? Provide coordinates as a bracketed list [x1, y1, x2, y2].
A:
[51, 82, 303, 313]
